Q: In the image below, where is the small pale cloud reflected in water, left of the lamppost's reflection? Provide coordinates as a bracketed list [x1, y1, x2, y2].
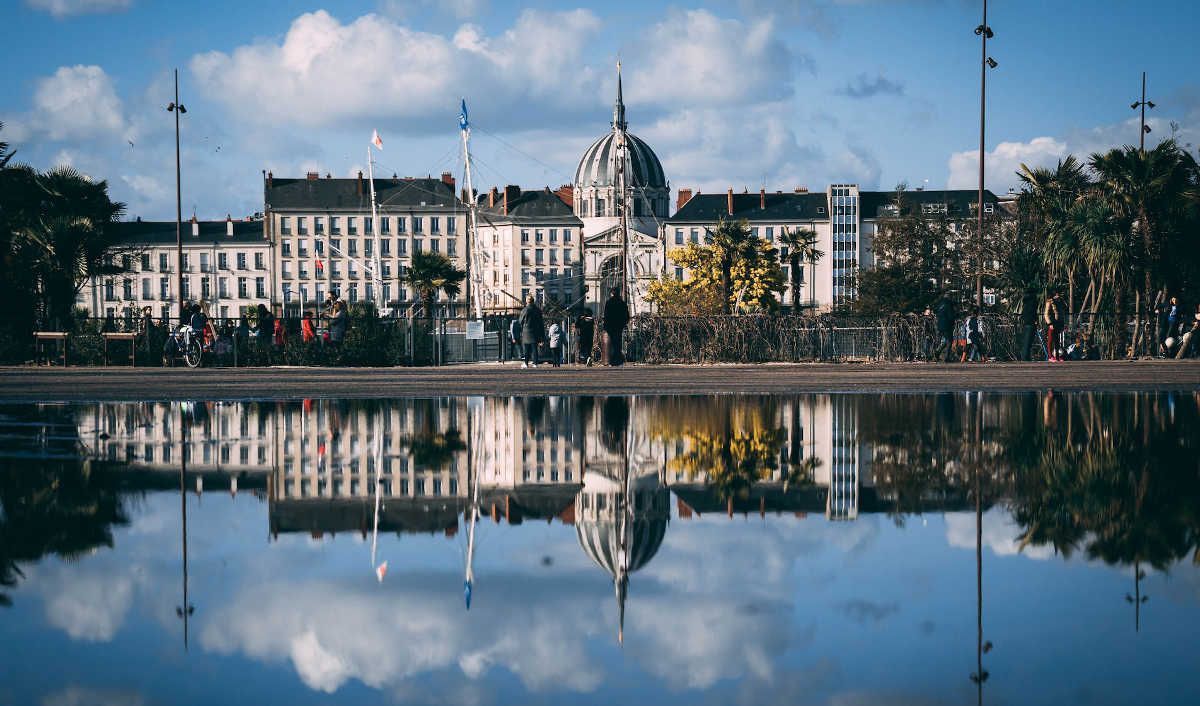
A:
[37, 566, 136, 642]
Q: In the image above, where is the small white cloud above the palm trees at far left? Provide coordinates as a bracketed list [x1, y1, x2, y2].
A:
[5, 65, 128, 140]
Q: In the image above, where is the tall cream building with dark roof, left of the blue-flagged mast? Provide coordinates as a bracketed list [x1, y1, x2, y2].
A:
[263, 172, 467, 316]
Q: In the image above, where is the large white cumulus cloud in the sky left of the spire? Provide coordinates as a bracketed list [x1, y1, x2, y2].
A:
[191, 10, 600, 128]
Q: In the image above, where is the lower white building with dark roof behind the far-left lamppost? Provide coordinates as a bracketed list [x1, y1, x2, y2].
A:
[77, 217, 274, 321]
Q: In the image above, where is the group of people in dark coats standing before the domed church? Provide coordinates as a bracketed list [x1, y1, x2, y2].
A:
[509, 287, 629, 367]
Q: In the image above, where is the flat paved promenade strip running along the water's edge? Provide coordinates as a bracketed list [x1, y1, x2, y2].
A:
[0, 360, 1200, 401]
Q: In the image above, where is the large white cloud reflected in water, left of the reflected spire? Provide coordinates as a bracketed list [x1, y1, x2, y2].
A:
[200, 576, 602, 693]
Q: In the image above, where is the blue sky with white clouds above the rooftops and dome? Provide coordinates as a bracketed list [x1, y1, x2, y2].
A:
[0, 0, 1200, 220]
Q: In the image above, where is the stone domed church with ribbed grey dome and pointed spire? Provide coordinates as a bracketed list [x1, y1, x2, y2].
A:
[572, 64, 671, 313]
